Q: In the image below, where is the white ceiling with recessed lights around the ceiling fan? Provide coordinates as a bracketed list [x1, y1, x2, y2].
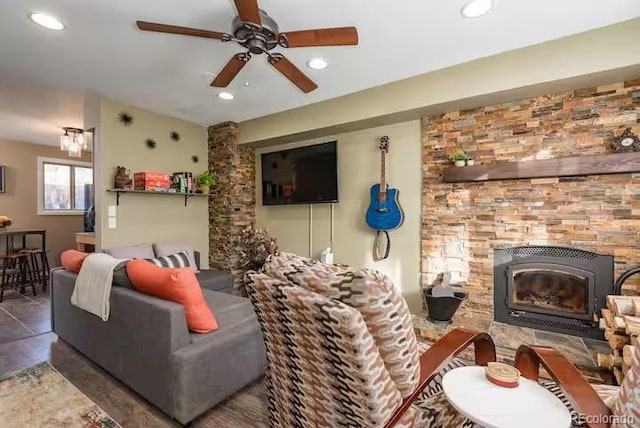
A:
[0, 0, 640, 144]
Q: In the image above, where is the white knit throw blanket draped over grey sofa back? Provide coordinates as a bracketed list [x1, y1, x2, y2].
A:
[71, 253, 124, 321]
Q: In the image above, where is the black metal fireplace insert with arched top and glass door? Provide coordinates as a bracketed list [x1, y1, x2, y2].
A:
[493, 246, 613, 339]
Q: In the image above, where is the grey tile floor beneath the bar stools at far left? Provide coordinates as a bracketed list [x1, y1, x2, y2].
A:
[0, 289, 51, 344]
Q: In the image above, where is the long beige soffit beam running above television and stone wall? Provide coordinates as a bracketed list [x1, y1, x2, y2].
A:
[239, 18, 640, 144]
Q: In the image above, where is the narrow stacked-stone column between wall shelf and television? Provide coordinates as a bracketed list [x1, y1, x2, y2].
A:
[209, 122, 256, 290]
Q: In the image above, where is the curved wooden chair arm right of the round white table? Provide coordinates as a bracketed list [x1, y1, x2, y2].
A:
[516, 345, 611, 428]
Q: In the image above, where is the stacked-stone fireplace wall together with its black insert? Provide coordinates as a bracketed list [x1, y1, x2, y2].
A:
[421, 79, 640, 337]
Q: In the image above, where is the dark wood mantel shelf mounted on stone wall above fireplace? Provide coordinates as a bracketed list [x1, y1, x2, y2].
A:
[443, 152, 640, 183]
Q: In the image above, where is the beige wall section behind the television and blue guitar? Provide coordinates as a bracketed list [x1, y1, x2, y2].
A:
[256, 121, 421, 311]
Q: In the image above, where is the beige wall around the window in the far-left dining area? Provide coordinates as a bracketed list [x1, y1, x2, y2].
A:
[0, 140, 91, 265]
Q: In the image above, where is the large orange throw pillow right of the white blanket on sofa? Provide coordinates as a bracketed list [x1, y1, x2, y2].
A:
[127, 259, 218, 333]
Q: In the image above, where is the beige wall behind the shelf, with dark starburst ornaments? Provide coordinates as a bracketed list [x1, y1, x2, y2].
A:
[85, 99, 209, 266]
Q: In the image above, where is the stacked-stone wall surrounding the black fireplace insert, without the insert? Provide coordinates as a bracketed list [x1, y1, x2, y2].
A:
[421, 79, 640, 320]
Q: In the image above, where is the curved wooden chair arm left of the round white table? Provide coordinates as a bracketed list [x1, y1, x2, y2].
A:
[385, 328, 496, 428]
